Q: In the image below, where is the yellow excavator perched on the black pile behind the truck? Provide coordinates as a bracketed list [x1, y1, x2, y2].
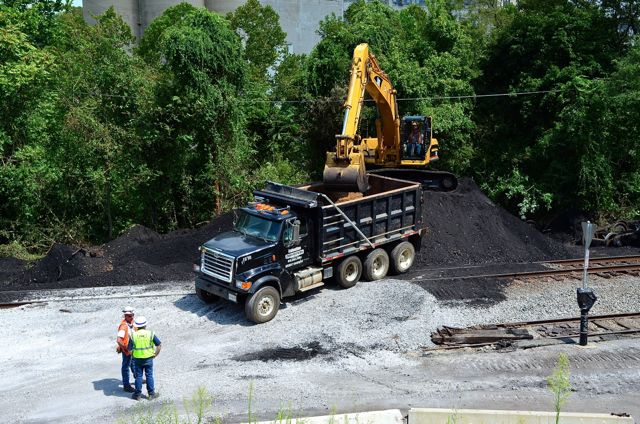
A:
[323, 43, 458, 193]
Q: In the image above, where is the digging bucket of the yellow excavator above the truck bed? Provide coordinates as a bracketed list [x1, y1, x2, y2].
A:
[322, 152, 369, 193]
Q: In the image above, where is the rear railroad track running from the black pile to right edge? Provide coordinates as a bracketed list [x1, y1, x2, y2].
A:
[414, 255, 640, 281]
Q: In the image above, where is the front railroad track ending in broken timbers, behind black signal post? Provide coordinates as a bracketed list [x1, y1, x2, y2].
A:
[427, 312, 640, 350]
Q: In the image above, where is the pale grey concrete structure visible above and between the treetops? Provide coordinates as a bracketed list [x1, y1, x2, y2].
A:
[82, 0, 424, 53]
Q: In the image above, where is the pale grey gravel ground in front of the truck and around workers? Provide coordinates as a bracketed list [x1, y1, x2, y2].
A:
[0, 277, 640, 423]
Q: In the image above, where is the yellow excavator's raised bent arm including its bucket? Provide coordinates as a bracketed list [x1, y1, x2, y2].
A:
[323, 44, 400, 192]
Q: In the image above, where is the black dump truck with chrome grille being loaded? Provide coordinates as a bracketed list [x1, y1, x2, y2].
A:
[194, 174, 425, 323]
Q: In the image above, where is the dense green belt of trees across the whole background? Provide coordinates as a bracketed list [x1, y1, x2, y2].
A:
[0, 0, 640, 251]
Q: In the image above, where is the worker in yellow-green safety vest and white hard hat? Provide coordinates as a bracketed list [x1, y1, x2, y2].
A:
[129, 316, 161, 400]
